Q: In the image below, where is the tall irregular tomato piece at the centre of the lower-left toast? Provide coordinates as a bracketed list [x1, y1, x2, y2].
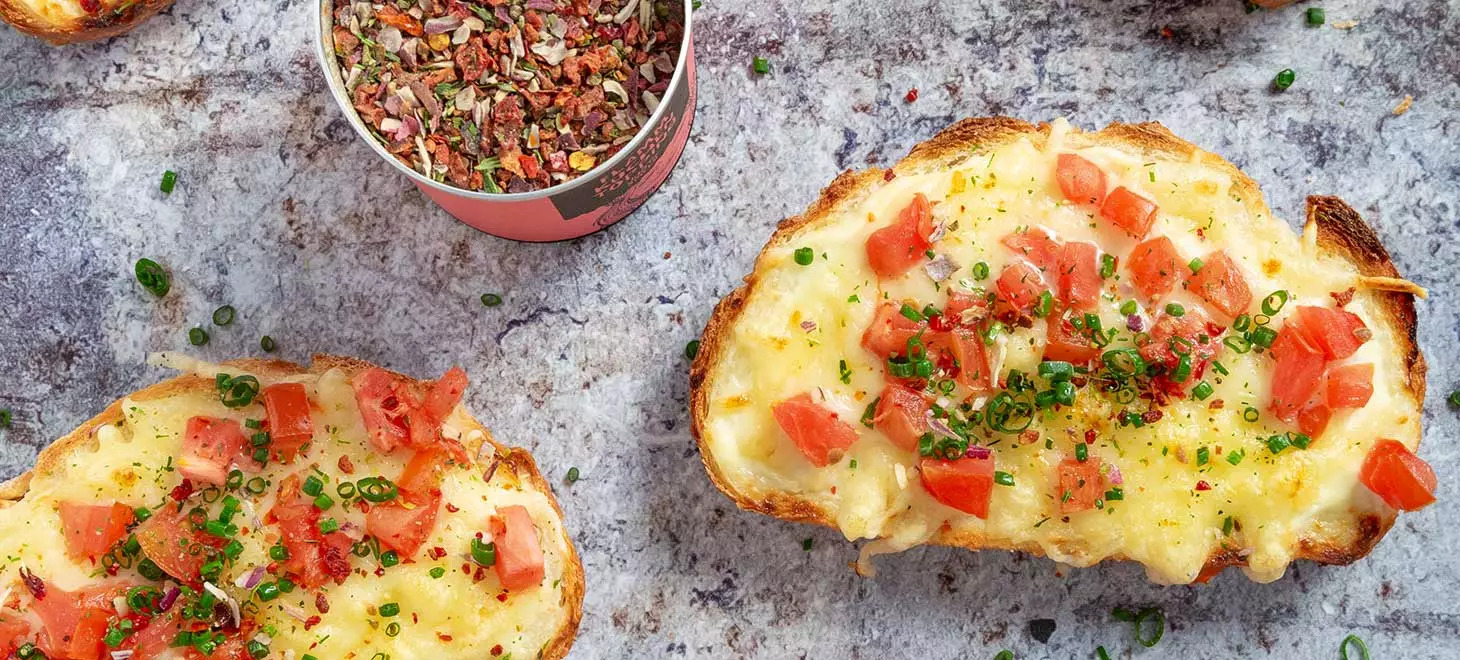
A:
[269, 475, 351, 588]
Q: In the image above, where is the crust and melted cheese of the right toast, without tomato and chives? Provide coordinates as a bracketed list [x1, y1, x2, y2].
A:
[691, 118, 1425, 583]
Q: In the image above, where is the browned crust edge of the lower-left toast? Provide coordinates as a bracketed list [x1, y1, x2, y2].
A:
[0, 355, 585, 660]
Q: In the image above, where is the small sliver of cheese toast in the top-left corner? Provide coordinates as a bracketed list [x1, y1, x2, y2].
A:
[0, 0, 172, 45]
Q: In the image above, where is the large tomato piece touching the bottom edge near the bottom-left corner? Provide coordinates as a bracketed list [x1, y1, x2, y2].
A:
[31, 584, 126, 660]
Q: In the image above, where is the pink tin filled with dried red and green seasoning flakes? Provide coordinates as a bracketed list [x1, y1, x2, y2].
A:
[318, 0, 695, 241]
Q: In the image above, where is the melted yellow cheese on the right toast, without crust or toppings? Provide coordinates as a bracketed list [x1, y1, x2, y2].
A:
[702, 121, 1419, 583]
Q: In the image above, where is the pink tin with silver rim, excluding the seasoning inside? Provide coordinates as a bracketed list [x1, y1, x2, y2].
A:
[315, 0, 695, 242]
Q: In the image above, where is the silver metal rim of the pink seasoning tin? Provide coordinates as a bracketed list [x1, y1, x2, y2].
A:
[314, 0, 694, 202]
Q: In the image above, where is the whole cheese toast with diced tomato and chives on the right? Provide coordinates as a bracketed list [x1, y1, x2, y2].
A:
[691, 118, 1434, 583]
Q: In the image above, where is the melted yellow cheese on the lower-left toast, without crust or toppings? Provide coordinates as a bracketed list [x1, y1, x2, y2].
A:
[0, 364, 572, 659]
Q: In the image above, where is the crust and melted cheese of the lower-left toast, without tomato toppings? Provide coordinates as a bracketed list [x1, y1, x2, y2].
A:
[0, 355, 584, 659]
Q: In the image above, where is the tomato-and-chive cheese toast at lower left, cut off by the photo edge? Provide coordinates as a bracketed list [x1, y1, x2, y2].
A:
[0, 356, 584, 660]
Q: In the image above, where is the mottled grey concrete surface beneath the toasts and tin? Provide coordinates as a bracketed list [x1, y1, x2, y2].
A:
[0, 0, 1460, 659]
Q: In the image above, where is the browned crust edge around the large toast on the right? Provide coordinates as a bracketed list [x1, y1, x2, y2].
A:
[689, 117, 1425, 581]
